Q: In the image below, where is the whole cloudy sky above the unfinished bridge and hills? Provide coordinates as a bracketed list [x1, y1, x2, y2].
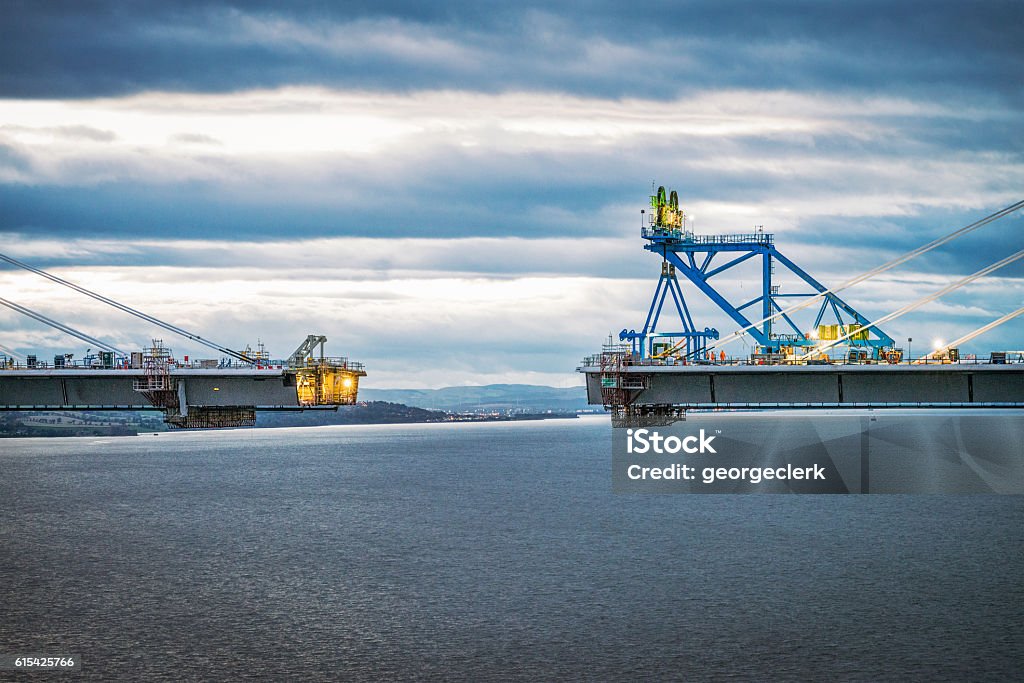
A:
[0, 0, 1024, 387]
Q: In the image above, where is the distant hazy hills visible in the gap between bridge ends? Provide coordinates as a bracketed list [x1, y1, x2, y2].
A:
[359, 384, 594, 413]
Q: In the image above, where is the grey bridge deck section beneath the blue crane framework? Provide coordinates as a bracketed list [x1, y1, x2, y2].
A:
[579, 364, 1024, 411]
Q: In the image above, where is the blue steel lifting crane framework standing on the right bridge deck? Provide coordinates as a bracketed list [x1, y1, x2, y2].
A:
[620, 188, 894, 358]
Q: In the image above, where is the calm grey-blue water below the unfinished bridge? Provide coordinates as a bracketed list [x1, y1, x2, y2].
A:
[0, 413, 1024, 681]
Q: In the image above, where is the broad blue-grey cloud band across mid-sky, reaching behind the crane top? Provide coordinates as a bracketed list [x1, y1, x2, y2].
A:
[0, 124, 1021, 268]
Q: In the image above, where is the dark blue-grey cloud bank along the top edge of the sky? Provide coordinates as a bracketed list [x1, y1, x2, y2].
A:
[0, 0, 1024, 104]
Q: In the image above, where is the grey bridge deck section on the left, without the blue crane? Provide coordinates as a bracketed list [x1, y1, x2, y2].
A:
[0, 368, 300, 411]
